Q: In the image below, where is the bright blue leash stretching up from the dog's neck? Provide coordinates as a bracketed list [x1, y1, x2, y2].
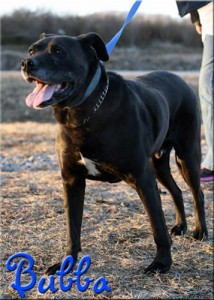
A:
[106, 0, 142, 55]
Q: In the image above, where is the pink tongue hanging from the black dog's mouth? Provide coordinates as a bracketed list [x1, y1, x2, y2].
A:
[25, 83, 56, 108]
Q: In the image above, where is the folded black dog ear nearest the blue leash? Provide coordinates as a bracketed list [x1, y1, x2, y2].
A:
[79, 32, 109, 61]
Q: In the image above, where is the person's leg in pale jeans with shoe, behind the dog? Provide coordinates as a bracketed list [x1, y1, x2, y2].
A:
[199, 35, 214, 180]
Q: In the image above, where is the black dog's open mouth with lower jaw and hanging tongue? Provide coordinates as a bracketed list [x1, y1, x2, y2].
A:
[25, 78, 74, 108]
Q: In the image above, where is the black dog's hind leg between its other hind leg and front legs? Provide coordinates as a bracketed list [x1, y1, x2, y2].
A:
[152, 151, 187, 235]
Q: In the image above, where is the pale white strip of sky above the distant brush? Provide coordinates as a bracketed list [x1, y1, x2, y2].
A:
[0, 0, 179, 18]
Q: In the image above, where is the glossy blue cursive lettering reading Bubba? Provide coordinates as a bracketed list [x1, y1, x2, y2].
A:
[6, 252, 111, 298]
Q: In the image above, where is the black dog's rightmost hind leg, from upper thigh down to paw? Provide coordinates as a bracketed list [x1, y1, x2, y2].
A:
[171, 89, 208, 240]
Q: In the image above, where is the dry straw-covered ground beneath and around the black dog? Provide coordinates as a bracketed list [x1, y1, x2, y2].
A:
[0, 73, 213, 299]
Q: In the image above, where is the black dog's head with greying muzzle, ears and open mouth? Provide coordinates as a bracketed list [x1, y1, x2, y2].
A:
[21, 33, 109, 108]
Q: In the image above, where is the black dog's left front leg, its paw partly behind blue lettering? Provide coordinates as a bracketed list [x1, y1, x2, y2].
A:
[46, 177, 85, 275]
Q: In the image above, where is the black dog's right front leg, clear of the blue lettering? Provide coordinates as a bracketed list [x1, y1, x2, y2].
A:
[136, 166, 172, 274]
